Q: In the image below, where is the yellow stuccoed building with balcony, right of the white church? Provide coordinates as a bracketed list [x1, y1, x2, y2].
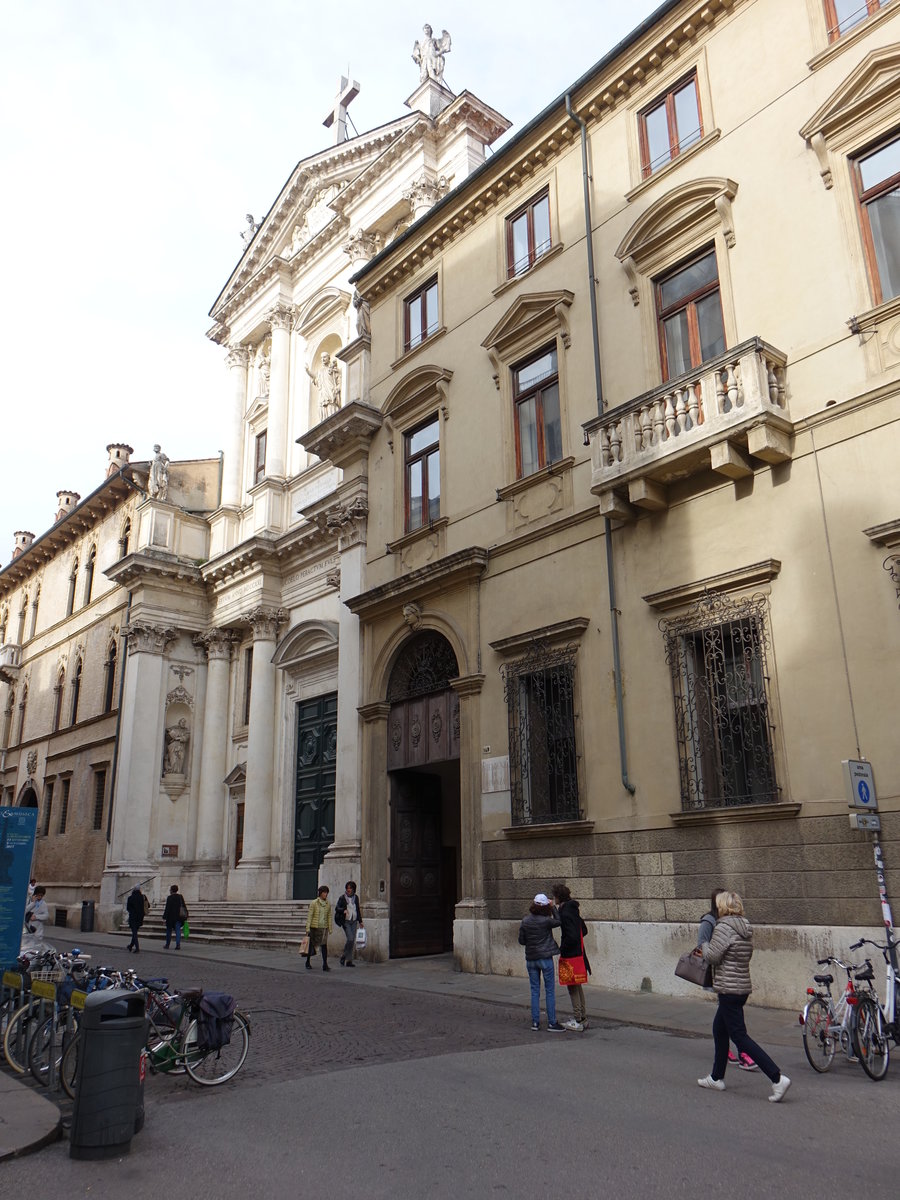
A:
[312, 0, 900, 1007]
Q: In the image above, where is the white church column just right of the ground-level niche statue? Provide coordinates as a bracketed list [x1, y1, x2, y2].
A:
[194, 629, 234, 865]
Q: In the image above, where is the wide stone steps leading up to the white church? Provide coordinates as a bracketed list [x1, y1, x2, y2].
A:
[120, 900, 310, 949]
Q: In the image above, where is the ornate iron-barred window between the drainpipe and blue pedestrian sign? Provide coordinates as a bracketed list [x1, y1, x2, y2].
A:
[660, 595, 779, 811]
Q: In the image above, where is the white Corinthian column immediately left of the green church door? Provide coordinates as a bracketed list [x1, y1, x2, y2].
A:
[239, 608, 286, 895]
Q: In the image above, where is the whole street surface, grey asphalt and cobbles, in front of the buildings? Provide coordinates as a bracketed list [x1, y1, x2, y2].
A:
[0, 947, 900, 1200]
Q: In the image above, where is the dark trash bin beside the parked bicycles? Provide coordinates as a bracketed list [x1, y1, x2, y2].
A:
[68, 988, 148, 1158]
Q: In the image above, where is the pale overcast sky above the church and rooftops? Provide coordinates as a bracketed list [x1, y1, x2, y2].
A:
[0, 0, 659, 552]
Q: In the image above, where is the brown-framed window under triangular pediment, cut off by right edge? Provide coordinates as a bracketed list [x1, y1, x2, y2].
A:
[853, 138, 900, 304]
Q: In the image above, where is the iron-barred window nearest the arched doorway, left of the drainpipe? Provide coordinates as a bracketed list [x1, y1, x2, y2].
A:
[502, 642, 581, 826]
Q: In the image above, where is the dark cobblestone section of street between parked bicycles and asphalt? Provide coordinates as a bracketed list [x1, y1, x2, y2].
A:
[125, 943, 578, 1103]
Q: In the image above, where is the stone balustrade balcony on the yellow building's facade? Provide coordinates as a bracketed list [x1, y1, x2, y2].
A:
[584, 337, 793, 520]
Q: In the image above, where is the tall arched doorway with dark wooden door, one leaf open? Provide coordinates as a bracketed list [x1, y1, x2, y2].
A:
[388, 631, 460, 958]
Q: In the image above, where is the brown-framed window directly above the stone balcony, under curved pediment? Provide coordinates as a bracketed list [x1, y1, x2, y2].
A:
[656, 250, 725, 379]
